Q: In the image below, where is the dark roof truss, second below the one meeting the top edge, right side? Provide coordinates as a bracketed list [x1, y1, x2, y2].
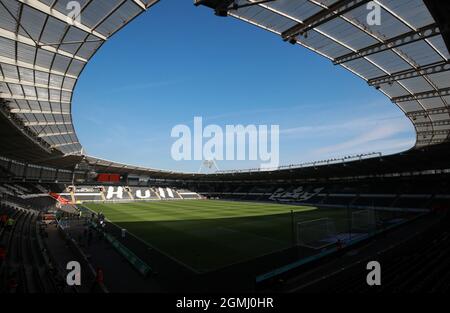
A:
[333, 23, 440, 65]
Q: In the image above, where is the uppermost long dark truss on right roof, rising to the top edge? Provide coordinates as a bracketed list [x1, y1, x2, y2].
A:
[281, 0, 370, 40]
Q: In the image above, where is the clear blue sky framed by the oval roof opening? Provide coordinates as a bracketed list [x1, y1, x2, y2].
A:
[73, 0, 415, 172]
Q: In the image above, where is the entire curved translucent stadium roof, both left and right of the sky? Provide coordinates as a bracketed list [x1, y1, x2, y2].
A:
[0, 0, 450, 171]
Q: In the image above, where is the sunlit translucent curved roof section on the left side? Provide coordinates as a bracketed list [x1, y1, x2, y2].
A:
[0, 0, 157, 160]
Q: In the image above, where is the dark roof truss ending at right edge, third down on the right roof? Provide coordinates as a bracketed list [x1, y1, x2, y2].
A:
[368, 60, 450, 86]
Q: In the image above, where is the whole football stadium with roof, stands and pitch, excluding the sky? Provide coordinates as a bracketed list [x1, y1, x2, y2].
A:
[0, 0, 450, 294]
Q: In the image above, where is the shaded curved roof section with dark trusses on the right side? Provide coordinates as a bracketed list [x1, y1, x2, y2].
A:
[196, 0, 450, 147]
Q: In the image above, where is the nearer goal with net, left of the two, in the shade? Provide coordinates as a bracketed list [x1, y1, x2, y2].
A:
[297, 218, 337, 249]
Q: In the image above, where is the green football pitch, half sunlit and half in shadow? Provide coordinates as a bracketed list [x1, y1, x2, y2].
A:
[84, 200, 346, 271]
